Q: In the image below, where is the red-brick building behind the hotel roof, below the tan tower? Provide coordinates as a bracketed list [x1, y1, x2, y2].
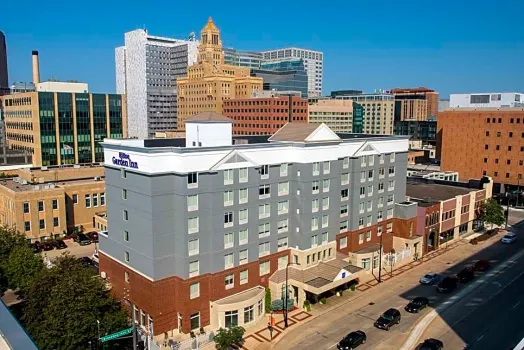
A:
[222, 93, 308, 135]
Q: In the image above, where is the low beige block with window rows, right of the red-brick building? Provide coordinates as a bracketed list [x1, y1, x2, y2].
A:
[309, 100, 353, 132]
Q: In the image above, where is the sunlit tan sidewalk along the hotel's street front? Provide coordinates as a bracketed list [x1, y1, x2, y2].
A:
[238, 240, 467, 350]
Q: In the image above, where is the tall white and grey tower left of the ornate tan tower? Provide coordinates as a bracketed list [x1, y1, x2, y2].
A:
[115, 29, 198, 138]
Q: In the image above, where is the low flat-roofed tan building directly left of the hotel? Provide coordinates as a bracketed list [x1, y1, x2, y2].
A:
[0, 165, 107, 241]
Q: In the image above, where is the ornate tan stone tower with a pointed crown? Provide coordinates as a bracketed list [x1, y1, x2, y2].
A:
[177, 17, 263, 131]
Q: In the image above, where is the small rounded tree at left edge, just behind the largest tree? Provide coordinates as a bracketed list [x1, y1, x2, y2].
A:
[3, 245, 44, 294]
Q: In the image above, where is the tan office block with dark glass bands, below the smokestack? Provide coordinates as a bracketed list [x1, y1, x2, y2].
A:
[0, 90, 127, 167]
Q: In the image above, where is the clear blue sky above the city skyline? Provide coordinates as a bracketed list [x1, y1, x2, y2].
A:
[0, 0, 524, 97]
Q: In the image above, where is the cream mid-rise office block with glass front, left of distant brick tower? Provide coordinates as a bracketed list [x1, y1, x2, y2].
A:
[336, 90, 395, 135]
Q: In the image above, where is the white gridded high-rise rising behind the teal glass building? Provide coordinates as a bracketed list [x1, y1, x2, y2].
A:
[262, 47, 324, 96]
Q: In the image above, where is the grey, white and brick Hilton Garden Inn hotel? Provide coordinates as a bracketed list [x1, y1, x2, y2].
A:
[99, 120, 418, 338]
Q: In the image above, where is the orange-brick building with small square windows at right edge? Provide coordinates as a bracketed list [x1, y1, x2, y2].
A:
[437, 107, 524, 192]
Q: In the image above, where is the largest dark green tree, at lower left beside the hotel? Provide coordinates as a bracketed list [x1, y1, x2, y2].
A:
[22, 254, 129, 350]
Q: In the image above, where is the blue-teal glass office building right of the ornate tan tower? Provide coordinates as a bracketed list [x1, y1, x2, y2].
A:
[251, 59, 308, 98]
